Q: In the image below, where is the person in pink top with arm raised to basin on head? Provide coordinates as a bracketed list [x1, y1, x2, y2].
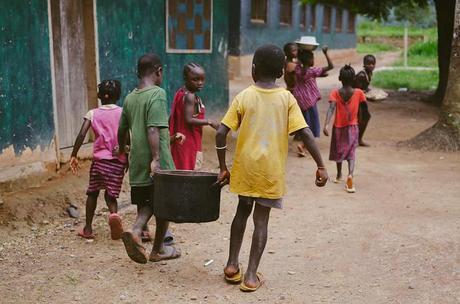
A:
[292, 46, 334, 157]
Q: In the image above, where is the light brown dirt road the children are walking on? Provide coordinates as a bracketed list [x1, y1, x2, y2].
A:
[0, 53, 460, 303]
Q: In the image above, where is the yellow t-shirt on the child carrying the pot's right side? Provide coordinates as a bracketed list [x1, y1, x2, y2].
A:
[222, 85, 307, 199]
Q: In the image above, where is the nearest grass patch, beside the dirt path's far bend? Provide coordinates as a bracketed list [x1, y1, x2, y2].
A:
[372, 70, 439, 91]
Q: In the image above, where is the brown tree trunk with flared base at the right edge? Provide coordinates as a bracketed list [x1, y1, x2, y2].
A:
[408, 0, 460, 151]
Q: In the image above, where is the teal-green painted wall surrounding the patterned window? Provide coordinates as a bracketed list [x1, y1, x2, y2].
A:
[96, 0, 228, 113]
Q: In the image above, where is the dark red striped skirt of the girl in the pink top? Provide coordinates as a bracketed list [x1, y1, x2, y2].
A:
[86, 159, 126, 198]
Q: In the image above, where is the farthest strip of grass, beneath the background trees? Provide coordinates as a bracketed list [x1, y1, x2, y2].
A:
[357, 21, 437, 40]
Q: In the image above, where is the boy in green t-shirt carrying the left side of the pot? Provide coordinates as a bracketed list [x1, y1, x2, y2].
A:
[118, 54, 180, 264]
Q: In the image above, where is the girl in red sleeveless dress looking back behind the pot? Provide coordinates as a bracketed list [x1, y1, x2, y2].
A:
[169, 62, 219, 170]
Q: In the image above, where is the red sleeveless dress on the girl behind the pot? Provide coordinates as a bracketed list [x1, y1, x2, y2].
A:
[169, 88, 206, 170]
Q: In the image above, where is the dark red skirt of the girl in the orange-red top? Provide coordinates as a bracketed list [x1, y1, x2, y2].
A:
[329, 125, 359, 163]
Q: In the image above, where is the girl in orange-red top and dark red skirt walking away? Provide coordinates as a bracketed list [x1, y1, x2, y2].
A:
[323, 65, 366, 193]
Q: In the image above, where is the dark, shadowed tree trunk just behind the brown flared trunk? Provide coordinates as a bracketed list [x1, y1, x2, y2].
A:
[434, 0, 455, 104]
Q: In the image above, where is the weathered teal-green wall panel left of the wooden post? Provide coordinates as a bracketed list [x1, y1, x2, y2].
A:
[0, 0, 54, 154]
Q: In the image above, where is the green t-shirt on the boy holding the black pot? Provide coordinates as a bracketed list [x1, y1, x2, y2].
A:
[118, 86, 175, 187]
